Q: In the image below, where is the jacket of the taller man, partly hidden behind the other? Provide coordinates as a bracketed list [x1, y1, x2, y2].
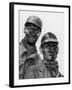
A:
[19, 39, 39, 79]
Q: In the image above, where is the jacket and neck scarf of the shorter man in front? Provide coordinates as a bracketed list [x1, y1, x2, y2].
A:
[24, 60, 63, 79]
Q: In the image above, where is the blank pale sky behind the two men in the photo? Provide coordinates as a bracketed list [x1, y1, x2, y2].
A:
[19, 11, 64, 75]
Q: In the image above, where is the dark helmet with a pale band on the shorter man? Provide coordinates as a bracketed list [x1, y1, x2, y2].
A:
[41, 32, 58, 46]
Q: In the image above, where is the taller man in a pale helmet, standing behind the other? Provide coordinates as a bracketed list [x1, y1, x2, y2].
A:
[19, 16, 42, 79]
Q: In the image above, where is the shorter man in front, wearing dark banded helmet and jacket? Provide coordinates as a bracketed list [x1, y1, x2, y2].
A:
[25, 32, 63, 78]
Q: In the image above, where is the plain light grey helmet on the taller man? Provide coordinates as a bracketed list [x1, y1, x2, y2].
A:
[25, 16, 42, 29]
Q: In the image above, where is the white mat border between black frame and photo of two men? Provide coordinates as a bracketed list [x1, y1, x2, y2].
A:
[14, 5, 69, 86]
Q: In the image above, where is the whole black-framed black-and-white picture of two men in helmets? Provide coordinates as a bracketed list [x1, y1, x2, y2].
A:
[9, 3, 70, 87]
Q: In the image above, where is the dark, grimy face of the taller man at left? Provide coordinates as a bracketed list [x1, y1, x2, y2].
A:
[25, 26, 41, 43]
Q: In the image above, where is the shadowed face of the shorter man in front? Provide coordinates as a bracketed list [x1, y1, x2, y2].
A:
[43, 42, 58, 61]
